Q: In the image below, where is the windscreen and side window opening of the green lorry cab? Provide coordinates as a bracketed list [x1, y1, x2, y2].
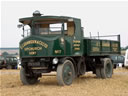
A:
[35, 22, 75, 36]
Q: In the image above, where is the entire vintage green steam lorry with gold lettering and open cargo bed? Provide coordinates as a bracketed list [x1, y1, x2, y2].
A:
[18, 11, 120, 86]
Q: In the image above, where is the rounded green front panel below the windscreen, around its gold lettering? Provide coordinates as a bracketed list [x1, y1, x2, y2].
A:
[20, 36, 64, 57]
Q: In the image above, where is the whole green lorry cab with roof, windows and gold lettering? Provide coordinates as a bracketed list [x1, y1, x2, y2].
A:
[19, 11, 83, 58]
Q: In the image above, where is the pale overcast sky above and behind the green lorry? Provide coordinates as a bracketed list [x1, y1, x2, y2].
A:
[1, 1, 128, 47]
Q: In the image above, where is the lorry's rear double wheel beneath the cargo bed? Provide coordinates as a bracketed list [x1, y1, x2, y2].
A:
[96, 58, 113, 79]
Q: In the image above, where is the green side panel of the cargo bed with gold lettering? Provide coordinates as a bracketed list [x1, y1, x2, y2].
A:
[84, 39, 120, 56]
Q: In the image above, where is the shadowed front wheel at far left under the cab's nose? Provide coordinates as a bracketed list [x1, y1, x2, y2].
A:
[20, 67, 38, 85]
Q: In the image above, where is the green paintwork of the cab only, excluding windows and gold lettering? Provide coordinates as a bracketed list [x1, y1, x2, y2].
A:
[19, 16, 82, 58]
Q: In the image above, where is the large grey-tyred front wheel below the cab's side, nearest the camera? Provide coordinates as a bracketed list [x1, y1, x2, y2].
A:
[57, 60, 75, 86]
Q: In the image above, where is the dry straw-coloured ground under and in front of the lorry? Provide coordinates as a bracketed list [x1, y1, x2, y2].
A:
[0, 68, 128, 96]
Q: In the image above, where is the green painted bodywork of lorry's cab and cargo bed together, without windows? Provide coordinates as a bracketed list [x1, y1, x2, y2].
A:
[19, 16, 120, 58]
